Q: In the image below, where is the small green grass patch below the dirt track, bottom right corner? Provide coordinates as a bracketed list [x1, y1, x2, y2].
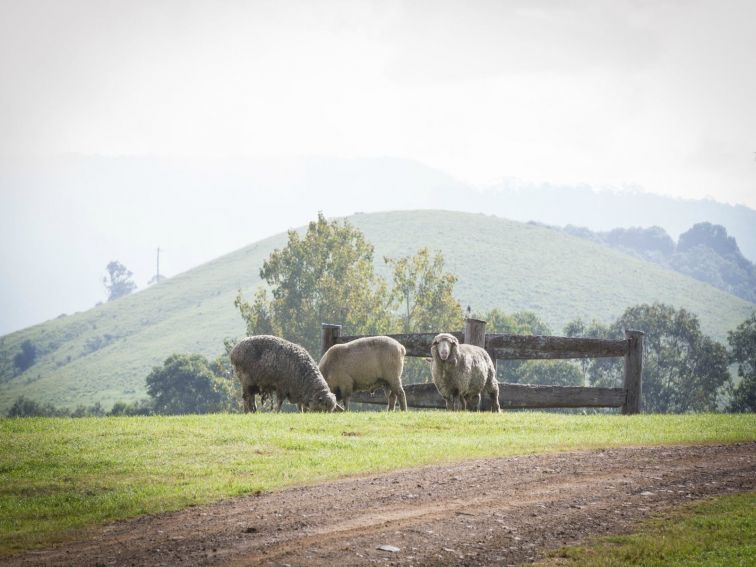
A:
[542, 492, 756, 567]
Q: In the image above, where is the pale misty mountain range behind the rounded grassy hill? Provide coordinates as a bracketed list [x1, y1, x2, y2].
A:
[0, 155, 756, 333]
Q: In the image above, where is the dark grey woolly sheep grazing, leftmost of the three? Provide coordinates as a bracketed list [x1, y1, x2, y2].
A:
[230, 335, 343, 413]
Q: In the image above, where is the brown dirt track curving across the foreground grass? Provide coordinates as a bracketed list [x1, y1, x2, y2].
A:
[0, 443, 756, 566]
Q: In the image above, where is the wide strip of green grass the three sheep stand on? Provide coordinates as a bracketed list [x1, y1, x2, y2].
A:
[0, 412, 756, 553]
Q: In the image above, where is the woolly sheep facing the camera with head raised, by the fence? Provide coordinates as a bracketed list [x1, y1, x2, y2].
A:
[431, 333, 501, 412]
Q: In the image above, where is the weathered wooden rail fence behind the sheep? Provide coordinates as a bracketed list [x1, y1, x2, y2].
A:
[321, 319, 643, 414]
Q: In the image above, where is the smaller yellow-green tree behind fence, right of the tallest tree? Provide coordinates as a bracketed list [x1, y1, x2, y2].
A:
[384, 248, 464, 333]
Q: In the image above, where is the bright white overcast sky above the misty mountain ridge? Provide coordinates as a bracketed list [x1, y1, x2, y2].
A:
[0, 0, 756, 208]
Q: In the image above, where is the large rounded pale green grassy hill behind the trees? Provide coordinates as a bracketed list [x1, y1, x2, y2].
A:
[0, 211, 756, 413]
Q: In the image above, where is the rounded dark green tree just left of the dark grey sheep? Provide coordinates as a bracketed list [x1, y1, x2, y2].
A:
[146, 354, 239, 415]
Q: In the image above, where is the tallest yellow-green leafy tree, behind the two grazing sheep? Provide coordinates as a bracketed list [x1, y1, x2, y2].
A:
[234, 213, 391, 359]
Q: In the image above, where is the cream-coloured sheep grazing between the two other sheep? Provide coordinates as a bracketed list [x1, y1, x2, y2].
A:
[318, 337, 407, 411]
